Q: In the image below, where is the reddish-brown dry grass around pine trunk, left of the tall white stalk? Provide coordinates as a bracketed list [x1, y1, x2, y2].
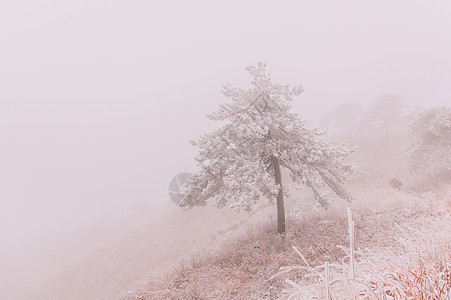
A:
[125, 212, 352, 299]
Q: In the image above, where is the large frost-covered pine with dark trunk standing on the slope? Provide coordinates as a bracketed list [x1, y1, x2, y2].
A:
[179, 63, 352, 233]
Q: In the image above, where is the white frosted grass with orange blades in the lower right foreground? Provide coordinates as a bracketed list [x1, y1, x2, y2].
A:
[276, 191, 451, 300]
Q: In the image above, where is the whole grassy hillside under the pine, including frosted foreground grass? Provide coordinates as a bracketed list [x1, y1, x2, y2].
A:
[127, 184, 451, 300]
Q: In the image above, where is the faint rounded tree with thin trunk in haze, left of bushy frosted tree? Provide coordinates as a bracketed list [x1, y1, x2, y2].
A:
[361, 94, 406, 140]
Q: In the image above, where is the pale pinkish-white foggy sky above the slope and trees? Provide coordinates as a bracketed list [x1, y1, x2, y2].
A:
[0, 0, 451, 282]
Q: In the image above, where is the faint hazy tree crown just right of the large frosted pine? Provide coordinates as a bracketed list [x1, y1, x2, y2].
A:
[319, 102, 363, 136]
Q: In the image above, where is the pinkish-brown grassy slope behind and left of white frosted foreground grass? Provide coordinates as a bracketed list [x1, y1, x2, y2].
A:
[127, 186, 451, 299]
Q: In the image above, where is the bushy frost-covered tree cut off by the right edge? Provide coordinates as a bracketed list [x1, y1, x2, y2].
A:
[405, 106, 451, 174]
